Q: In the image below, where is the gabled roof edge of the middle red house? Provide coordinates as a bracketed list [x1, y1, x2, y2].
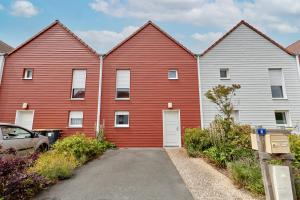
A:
[106, 20, 194, 56]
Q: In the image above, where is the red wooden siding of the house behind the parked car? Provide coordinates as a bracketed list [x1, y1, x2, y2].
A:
[0, 23, 99, 136]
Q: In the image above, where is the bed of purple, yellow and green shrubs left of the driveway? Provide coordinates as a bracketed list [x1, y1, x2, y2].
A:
[0, 134, 114, 200]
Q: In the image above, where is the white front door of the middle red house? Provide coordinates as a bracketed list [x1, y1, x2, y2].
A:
[163, 110, 181, 147]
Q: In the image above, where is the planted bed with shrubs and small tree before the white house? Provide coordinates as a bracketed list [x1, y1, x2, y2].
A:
[184, 85, 300, 198]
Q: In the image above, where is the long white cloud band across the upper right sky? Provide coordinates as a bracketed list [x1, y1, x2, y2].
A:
[90, 0, 300, 33]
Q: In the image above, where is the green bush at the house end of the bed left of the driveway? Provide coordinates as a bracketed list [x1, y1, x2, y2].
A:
[53, 134, 113, 164]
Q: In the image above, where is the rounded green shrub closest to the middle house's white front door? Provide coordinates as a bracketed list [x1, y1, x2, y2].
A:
[184, 128, 211, 157]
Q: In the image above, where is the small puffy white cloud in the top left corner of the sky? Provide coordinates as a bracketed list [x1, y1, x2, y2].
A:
[11, 0, 38, 17]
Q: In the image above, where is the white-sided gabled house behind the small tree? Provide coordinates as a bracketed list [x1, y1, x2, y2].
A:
[198, 21, 300, 128]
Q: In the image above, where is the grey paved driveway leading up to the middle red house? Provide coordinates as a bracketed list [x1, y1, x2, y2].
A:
[36, 149, 193, 200]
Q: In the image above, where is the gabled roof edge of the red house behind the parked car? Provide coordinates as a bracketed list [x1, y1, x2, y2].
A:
[8, 20, 99, 56]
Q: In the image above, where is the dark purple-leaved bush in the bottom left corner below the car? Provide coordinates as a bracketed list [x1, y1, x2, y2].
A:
[0, 150, 51, 200]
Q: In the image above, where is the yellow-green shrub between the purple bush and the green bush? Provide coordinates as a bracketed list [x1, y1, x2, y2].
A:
[29, 150, 79, 180]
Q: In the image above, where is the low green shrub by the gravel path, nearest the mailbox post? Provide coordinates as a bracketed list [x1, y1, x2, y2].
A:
[227, 158, 264, 194]
